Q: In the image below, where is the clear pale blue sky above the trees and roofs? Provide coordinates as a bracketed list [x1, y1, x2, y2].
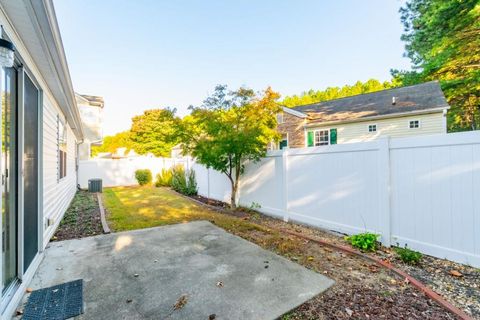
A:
[54, 0, 409, 134]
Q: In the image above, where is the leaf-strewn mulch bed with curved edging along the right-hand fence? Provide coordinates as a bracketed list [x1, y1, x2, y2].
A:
[190, 196, 480, 320]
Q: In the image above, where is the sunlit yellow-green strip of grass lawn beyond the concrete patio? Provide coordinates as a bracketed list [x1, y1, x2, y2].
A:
[103, 186, 263, 234]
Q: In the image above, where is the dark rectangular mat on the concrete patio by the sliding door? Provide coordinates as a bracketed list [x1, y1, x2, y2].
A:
[22, 279, 83, 320]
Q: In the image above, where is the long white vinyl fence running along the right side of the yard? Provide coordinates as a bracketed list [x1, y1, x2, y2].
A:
[192, 132, 480, 267]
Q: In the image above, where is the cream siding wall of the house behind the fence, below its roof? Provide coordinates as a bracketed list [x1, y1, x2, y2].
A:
[307, 112, 446, 144]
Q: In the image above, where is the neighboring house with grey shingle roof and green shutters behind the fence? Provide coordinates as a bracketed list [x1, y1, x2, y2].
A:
[277, 81, 450, 149]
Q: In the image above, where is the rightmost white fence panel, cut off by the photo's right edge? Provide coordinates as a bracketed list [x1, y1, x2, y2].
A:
[391, 133, 480, 266]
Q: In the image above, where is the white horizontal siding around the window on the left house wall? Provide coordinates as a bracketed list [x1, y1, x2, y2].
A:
[43, 102, 77, 246]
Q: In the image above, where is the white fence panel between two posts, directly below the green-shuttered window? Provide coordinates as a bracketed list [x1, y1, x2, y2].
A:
[287, 142, 386, 234]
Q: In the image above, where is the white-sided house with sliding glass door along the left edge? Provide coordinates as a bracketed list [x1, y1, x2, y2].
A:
[0, 0, 84, 319]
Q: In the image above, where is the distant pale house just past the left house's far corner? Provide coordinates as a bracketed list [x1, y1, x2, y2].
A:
[75, 93, 105, 160]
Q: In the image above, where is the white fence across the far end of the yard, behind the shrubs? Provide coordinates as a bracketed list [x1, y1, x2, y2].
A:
[78, 157, 189, 189]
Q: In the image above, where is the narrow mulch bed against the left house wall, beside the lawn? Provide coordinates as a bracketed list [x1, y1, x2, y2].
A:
[51, 190, 103, 241]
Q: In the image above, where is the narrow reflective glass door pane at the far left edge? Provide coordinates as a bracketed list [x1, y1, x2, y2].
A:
[1, 68, 17, 291]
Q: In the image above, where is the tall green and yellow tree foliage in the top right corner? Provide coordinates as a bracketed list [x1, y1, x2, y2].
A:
[392, 0, 480, 131]
